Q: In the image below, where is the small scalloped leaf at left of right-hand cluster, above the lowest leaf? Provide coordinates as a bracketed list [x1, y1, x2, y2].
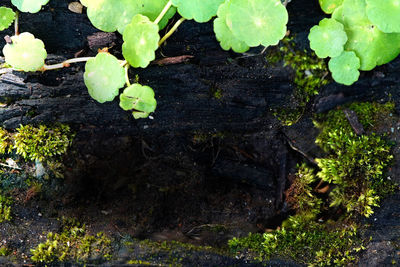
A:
[308, 19, 347, 58]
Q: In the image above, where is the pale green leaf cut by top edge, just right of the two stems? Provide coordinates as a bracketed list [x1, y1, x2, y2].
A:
[172, 0, 224, 22]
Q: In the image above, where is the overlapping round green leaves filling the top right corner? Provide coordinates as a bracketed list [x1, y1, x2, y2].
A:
[308, 0, 400, 85]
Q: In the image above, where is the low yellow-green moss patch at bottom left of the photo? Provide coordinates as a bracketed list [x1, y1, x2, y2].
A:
[31, 220, 111, 263]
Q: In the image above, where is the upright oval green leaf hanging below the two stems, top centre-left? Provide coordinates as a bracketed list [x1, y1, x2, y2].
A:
[122, 14, 160, 68]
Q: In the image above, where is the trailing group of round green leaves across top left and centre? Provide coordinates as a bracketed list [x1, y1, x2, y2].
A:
[0, 0, 288, 118]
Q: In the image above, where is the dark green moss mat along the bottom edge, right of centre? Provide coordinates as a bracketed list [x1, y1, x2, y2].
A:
[229, 214, 363, 266]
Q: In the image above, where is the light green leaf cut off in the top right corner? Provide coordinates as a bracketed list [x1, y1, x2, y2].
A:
[366, 0, 400, 33]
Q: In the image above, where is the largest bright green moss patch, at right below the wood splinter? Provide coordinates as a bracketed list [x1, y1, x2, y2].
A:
[315, 103, 396, 217]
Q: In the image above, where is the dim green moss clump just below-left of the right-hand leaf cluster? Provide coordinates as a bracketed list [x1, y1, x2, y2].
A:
[267, 37, 329, 126]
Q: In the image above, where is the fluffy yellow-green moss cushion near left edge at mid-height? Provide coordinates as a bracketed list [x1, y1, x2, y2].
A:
[13, 124, 73, 161]
